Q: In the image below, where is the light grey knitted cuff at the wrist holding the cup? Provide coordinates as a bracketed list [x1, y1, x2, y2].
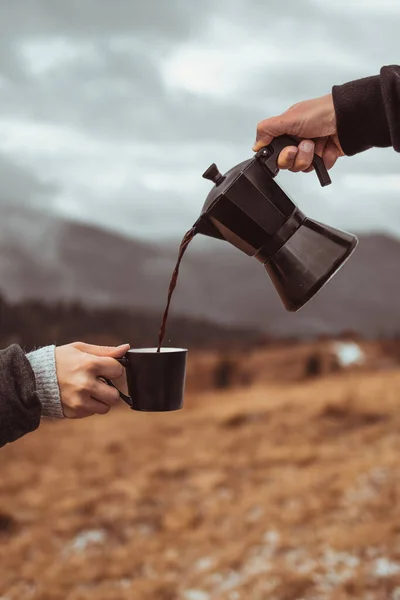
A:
[27, 346, 64, 419]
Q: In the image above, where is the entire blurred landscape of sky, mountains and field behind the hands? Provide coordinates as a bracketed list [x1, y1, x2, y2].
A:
[0, 0, 400, 600]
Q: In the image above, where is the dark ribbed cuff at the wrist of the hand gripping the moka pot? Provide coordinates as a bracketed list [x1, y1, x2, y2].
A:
[332, 75, 392, 156]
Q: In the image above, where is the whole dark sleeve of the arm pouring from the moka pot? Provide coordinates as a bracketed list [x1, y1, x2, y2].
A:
[332, 65, 400, 156]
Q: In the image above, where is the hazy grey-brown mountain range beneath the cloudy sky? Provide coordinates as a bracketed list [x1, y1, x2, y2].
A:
[0, 206, 400, 337]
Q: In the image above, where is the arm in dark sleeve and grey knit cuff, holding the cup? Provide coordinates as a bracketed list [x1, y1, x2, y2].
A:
[0, 342, 129, 447]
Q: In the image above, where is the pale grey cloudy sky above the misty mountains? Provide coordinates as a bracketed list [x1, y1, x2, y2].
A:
[0, 0, 400, 238]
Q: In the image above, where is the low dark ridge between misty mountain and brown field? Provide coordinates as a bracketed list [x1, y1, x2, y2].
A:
[0, 298, 262, 353]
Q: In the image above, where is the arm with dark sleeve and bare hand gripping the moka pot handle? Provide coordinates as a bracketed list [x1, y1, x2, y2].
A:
[253, 65, 400, 172]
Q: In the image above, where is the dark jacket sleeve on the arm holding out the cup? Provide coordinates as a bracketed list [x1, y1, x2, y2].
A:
[0, 344, 41, 447]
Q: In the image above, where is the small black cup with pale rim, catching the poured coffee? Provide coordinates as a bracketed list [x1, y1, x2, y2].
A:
[103, 348, 187, 412]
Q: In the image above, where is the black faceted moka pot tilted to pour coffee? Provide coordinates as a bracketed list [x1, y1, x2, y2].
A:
[195, 135, 358, 312]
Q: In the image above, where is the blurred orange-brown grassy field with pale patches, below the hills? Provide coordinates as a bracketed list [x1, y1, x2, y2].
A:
[0, 344, 400, 600]
